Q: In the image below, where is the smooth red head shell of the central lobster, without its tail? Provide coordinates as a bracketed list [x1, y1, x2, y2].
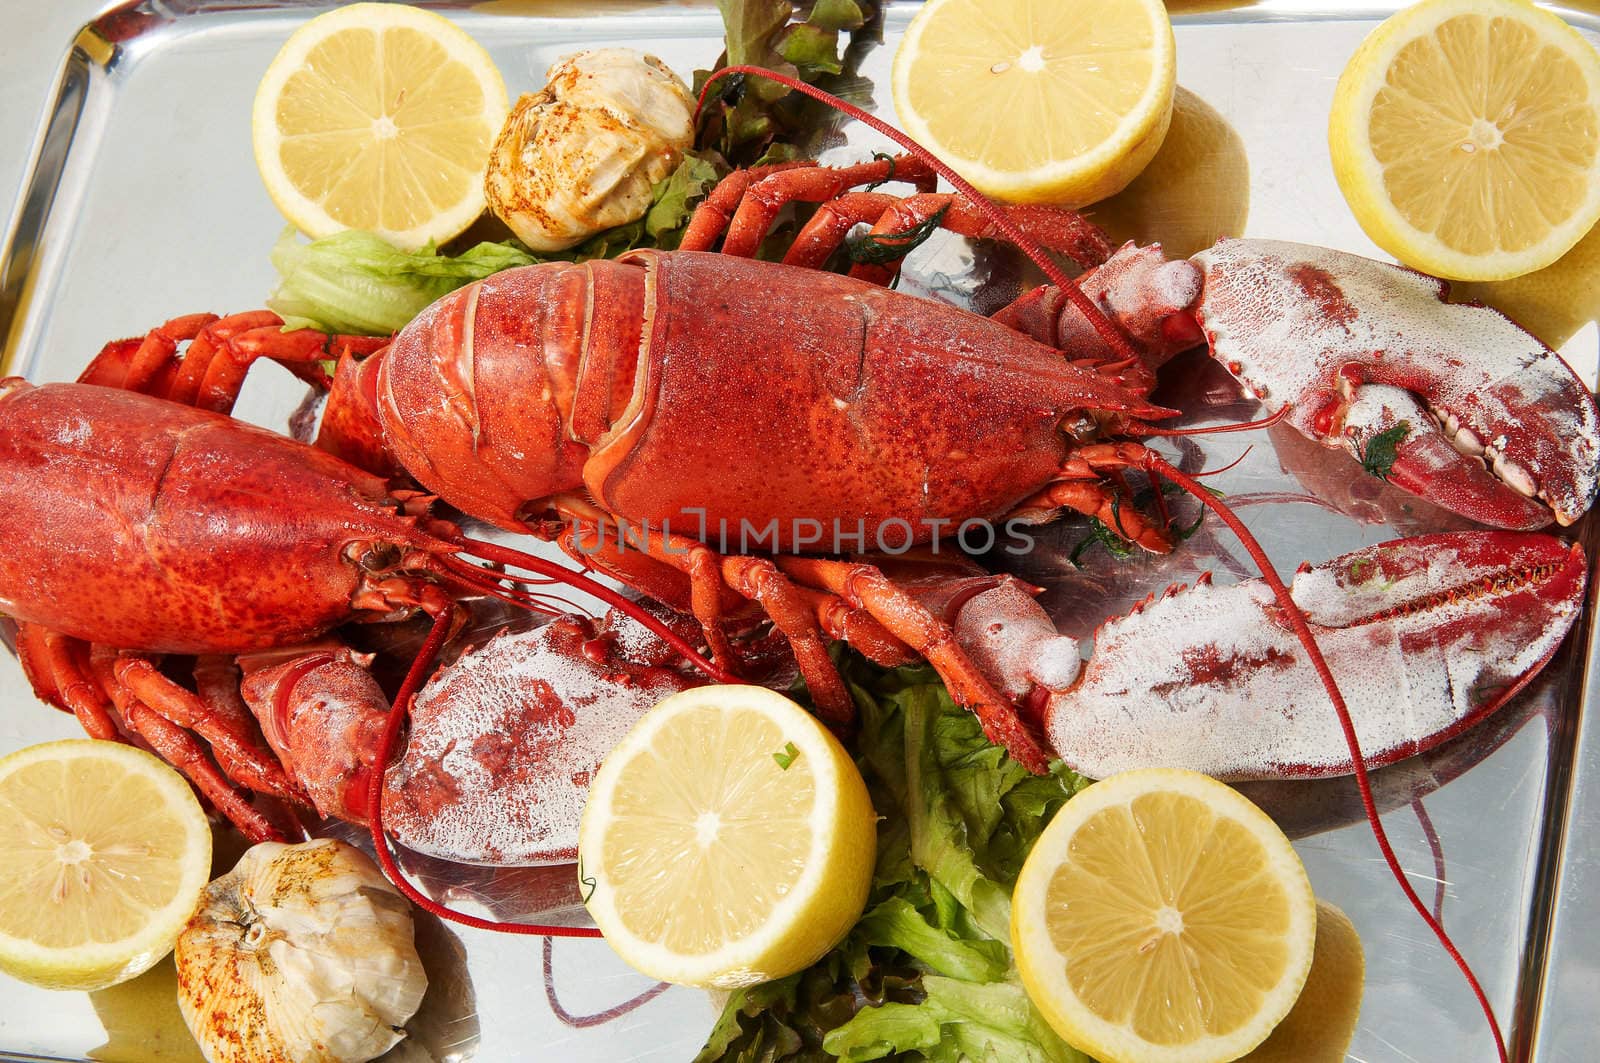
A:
[584, 251, 1165, 549]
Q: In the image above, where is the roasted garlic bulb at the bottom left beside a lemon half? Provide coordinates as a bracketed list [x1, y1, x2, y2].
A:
[174, 839, 427, 1063]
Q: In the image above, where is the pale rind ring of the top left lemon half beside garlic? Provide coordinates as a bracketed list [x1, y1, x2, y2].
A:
[251, 3, 510, 250]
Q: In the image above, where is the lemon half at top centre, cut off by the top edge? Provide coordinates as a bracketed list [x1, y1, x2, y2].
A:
[891, 0, 1176, 207]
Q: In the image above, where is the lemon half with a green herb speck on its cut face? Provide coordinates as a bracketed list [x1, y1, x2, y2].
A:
[578, 685, 877, 989]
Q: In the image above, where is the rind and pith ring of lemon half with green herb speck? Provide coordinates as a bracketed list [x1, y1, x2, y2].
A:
[578, 685, 875, 989]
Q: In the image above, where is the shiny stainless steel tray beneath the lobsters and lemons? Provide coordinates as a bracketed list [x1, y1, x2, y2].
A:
[0, 0, 1600, 1063]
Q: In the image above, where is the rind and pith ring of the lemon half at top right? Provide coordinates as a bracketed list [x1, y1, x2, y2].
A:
[1328, 0, 1600, 280]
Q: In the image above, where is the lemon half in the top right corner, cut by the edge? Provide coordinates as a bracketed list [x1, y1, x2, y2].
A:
[1328, 0, 1600, 280]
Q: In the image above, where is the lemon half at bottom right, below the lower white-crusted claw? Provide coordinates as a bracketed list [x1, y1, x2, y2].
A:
[1011, 768, 1317, 1063]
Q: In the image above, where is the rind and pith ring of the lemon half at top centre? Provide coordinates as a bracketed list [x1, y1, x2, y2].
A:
[890, 0, 1178, 207]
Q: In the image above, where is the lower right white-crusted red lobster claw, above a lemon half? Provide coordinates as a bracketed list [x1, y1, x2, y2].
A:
[958, 532, 1587, 780]
